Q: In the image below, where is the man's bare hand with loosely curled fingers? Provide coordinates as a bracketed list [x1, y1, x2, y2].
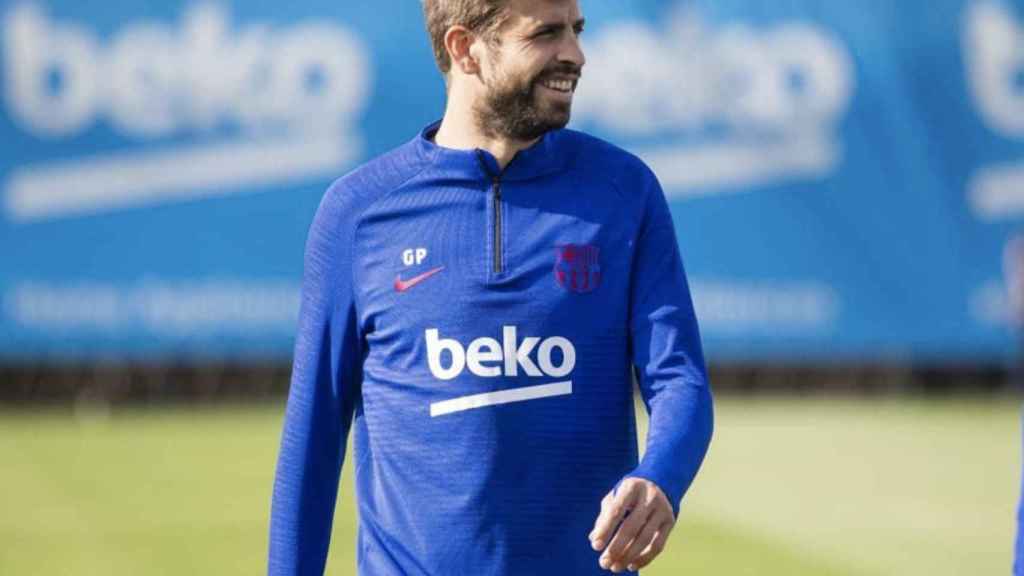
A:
[590, 478, 676, 574]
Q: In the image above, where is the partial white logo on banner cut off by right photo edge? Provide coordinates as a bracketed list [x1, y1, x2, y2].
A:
[964, 0, 1024, 219]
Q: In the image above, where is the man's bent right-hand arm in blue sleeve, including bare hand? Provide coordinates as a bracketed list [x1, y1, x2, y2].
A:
[591, 166, 714, 572]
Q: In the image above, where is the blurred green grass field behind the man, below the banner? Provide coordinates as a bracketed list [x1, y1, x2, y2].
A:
[0, 398, 1021, 576]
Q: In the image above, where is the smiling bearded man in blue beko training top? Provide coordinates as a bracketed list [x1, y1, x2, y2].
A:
[269, 0, 712, 576]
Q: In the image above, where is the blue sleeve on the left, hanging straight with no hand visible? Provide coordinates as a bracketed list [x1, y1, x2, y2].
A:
[267, 184, 361, 576]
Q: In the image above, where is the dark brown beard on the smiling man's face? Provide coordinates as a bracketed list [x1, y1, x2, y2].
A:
[474, 63, 580, 141]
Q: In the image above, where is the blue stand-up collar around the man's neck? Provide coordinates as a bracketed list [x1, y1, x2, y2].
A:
[416, 120, 568, 181]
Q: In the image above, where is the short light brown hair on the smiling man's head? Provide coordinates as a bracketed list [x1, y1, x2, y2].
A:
[423, 0, 509, 76]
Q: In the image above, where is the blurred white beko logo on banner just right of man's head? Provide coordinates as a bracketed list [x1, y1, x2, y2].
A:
[574, 10, 854, 196]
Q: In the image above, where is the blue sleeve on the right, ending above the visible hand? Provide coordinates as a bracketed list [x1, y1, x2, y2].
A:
[629, 167, 714, 517]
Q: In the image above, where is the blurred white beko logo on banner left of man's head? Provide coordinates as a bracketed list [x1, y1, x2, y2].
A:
[2, 3, 371, 221]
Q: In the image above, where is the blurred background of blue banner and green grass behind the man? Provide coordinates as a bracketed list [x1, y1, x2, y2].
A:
[0, 0, 1024, 576]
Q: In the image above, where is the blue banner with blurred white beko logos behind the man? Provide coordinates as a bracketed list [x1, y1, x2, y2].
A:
[0, 0, 1024, 362]
